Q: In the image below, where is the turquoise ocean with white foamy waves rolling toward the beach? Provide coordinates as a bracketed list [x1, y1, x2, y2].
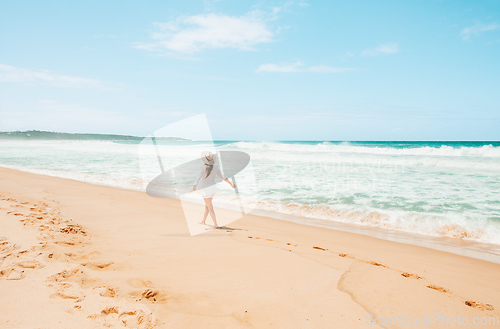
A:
[0, 140, 500, 245]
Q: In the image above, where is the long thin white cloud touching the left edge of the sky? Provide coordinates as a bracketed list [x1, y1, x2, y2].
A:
[0, 64, 107, 89]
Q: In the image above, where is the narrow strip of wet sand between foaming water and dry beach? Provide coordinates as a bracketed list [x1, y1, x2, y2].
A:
[0, 166, 500, 264]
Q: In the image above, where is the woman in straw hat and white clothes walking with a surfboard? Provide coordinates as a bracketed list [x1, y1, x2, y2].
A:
[193, 151, 235, 228]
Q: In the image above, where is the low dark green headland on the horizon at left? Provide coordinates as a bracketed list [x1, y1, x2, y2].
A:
[0, 130, 188, 141]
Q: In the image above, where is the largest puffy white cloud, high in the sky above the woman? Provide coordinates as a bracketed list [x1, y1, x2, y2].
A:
[135, 10, 274, 54]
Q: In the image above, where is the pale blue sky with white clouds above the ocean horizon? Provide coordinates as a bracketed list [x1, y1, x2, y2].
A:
[0, 0, 500, 140]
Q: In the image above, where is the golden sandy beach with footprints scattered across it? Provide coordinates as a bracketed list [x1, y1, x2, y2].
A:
[0, 168, 500, 329]
